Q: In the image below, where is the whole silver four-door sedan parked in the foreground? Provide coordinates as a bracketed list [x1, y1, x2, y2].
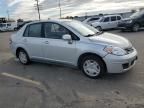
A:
[10, 20, 137, 78]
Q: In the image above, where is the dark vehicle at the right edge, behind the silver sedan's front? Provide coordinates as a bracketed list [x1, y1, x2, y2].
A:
[118, 11, 144, 32]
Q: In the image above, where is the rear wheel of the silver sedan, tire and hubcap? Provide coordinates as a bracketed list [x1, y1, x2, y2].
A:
[18, 49, 30, 65]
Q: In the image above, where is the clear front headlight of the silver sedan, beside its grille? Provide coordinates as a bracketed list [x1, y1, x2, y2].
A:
[104, 46, 127, 56]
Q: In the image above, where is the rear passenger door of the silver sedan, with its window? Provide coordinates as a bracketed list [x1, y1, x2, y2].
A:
[21, 23, 44, 58]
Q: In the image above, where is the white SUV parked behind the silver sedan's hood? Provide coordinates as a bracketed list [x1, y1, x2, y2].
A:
[92, 15, 122, 31]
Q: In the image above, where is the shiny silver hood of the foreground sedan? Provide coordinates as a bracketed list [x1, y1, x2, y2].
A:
[89, 33, 132, 49]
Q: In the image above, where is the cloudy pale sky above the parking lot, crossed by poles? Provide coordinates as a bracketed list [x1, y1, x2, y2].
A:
[0, 0, 144, 20]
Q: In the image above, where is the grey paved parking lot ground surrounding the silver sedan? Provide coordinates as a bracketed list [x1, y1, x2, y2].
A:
[0, 30, 144, 108]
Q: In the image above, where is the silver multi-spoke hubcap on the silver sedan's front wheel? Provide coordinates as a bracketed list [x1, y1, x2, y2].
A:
[83, 60, 101, 77]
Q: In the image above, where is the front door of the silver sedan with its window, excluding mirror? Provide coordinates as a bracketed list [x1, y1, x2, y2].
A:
[44, 22, 76, 64]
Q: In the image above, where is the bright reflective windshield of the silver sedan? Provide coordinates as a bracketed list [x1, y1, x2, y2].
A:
[65, 21, 100, 37]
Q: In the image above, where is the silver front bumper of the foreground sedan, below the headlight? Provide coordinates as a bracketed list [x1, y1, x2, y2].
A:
[103, 49, 138, 73]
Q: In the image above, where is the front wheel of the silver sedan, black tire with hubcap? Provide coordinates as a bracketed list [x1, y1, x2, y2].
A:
[80, 55, 106, 79]
